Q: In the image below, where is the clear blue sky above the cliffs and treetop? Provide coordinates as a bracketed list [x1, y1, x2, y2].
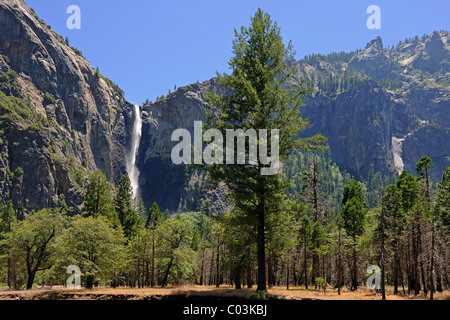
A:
[26, 0, 450, 104]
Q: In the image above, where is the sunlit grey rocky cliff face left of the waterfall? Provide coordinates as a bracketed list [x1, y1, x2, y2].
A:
[0, 0, 132, 216]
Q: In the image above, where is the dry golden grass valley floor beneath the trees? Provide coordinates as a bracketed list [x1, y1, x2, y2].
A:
[0, 286, 450, 300]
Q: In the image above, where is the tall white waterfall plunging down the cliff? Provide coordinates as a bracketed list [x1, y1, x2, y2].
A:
[126, 105, 142, 199]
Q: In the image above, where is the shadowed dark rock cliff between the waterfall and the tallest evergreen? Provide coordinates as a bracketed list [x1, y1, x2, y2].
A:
[137, 80, 229, 213]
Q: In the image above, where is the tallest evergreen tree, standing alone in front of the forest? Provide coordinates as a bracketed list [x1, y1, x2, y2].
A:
[207, 9, 324, 291]
